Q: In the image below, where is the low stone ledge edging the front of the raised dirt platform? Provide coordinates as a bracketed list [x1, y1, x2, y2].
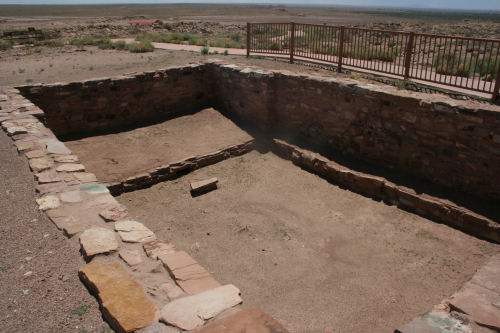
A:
[105, 140, 255, 195]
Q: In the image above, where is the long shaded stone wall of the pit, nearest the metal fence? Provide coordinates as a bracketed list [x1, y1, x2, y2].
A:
[211, 65, 500, 202]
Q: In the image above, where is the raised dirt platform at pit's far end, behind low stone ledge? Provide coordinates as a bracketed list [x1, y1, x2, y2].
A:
[66, 108, 252, 183]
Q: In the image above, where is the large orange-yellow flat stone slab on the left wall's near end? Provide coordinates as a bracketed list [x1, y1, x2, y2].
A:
[79, 260, 157, 332]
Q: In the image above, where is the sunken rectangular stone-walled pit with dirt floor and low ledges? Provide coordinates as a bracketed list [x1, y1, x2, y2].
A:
[20, 64, 500, 332]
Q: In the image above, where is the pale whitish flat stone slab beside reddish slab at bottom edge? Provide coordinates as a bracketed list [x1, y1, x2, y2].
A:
[160, 284, 241, 330]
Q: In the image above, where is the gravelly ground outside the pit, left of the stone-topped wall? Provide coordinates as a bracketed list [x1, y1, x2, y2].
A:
[0, 132, 110, 333]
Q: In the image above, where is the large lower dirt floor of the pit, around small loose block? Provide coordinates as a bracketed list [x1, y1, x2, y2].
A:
[118, 151, 500, 333]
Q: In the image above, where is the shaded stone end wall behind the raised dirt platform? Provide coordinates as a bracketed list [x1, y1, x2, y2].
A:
[19, 66, 213, 136]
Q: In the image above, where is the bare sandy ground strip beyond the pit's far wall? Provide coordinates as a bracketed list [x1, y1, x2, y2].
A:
[0, 46, 339, 85]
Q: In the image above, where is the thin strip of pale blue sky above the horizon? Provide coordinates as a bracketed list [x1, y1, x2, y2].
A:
[0, 0, 500, 10]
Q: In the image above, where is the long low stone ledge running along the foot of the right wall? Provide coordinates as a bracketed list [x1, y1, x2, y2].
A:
[272, 139, 500, 243]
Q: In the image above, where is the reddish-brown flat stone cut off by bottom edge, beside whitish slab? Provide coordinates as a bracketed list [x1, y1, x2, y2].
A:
[195, 308, 292, 333]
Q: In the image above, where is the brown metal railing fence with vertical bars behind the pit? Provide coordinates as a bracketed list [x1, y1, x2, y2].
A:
[247, 23, 500, 100]
